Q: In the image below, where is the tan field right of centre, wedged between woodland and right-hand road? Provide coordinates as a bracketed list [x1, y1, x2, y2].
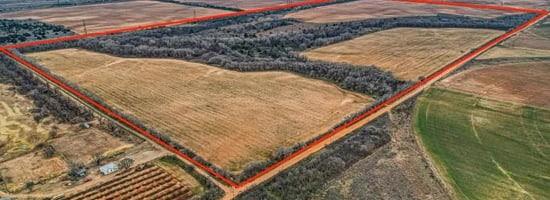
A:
[304, 28, 503, 80]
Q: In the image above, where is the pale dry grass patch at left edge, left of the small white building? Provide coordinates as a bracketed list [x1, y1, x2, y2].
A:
[0, 153, 68, 192]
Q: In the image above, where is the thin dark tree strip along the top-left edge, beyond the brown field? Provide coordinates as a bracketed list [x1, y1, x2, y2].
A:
[0, 0, 123, 13]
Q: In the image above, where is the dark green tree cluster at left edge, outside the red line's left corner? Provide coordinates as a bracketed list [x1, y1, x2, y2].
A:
[0, 19, 72, 45]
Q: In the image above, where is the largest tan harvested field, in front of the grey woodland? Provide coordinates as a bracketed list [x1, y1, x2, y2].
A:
[29, 49, 372, 171]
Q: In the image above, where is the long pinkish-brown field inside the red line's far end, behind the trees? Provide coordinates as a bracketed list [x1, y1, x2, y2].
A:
[286, 0, 506, 23]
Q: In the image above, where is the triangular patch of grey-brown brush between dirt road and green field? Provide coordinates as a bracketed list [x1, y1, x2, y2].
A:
[237, 116, 390, 199]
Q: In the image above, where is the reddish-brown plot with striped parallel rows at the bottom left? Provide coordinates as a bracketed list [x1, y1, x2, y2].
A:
[63, 165, 193, 200]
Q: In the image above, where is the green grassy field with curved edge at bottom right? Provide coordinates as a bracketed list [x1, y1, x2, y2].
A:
[414, 88, 550, 199]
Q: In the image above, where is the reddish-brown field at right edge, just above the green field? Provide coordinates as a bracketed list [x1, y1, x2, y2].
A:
[440, 62, 550, 108]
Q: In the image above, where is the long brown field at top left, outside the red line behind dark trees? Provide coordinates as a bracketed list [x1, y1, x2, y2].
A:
[0, 1, 228, 33]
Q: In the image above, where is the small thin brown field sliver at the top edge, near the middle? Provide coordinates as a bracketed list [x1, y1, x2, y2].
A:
[177, 0, 303, 9]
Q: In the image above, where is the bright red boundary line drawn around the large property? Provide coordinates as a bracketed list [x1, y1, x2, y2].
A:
[0, 0, 549, 189]
